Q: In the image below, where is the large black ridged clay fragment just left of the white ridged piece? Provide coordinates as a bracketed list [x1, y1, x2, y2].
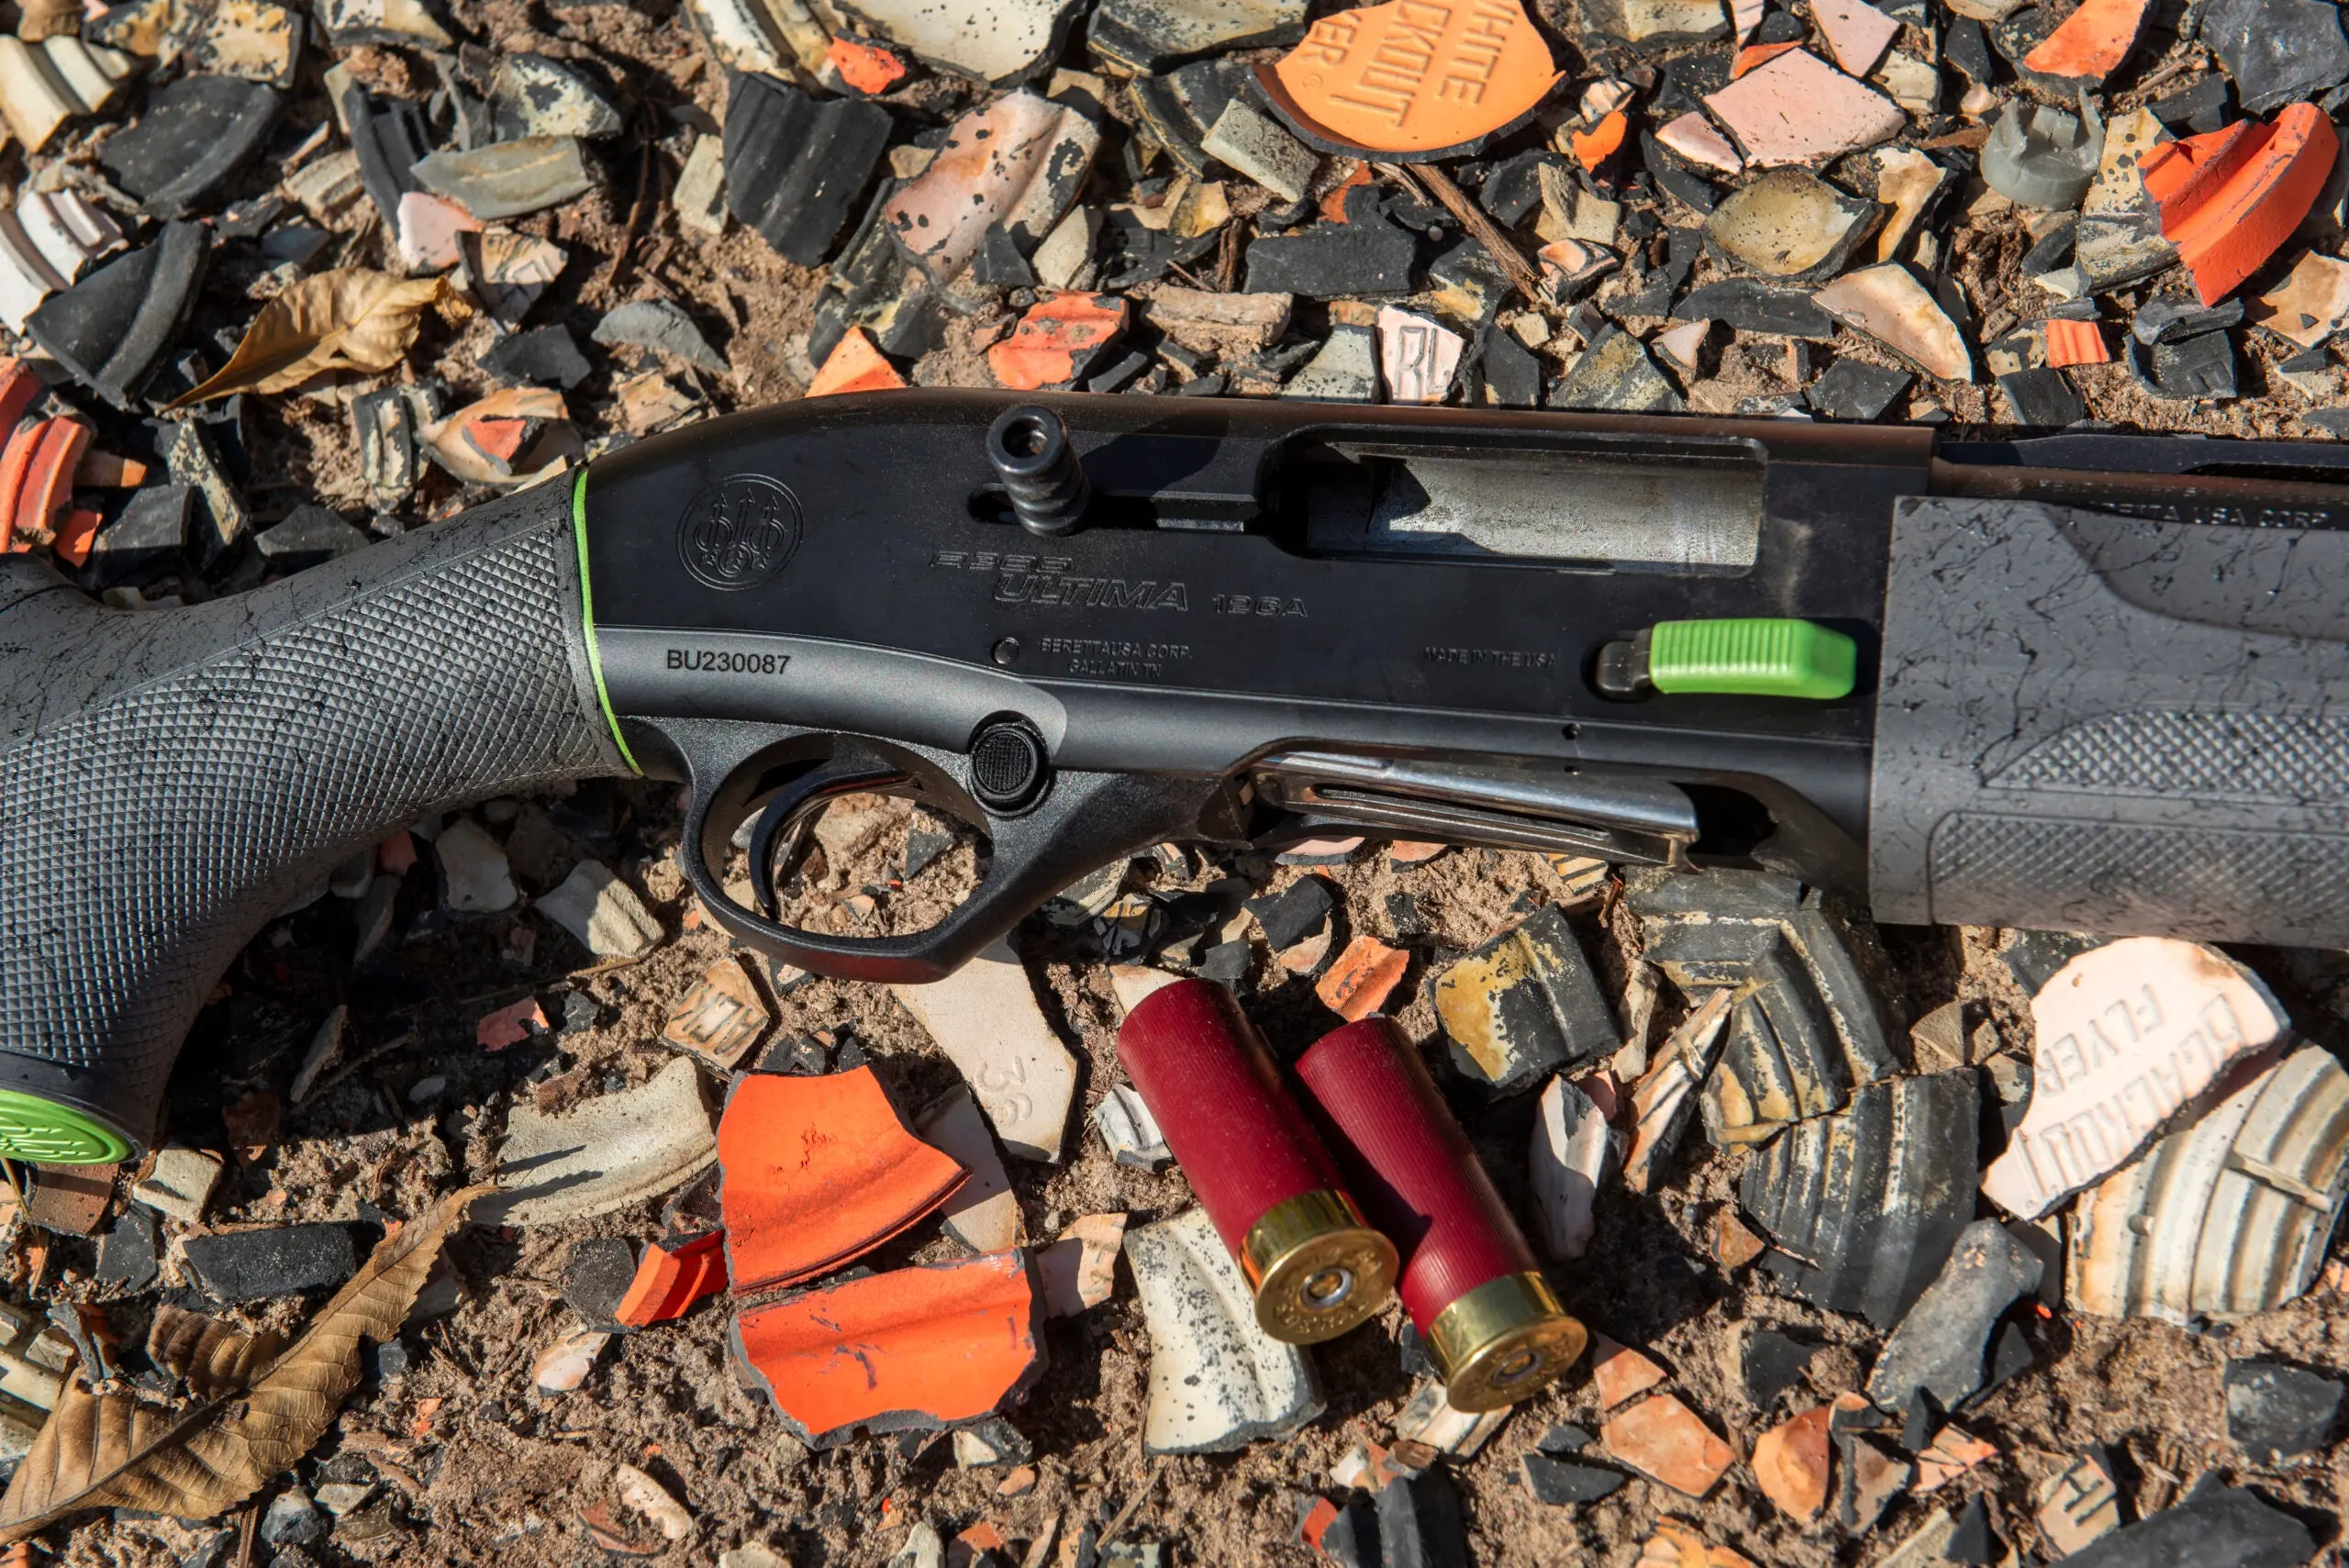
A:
[1738, 1068, 1980, 1329]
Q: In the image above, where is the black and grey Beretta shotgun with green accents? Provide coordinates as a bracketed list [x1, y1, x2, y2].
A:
[0, 392, 2349, 1162]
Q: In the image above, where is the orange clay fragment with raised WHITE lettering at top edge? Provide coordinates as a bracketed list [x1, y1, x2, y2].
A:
[1257, 0, 1562, 160]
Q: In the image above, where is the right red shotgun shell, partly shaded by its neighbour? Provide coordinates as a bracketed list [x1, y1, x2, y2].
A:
[1297, 1014, 1586, 1411]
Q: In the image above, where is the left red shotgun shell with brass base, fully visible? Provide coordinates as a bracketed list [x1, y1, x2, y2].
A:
[1119, 979, 1396, 1345]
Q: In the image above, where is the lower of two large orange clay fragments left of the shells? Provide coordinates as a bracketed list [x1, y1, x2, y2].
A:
[733, 1249, 1043, 1446]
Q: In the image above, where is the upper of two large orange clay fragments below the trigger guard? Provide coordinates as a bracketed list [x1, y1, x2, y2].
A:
[718, 1066, 963, 1291]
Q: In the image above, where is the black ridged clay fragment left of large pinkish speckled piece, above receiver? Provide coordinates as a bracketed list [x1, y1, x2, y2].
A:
[726, 72, 890, 268]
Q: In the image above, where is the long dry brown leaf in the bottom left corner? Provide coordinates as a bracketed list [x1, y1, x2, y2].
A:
[0, 1185, 494, 1540]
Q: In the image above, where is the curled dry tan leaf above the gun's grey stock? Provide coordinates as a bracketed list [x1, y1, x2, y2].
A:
[164, 268, 470, 413]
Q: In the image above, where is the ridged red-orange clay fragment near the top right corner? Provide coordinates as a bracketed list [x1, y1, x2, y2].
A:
[2143, 104, 2340, 306]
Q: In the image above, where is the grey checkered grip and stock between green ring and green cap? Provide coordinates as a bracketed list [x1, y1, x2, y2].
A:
[0, 486, 620, 1136]
